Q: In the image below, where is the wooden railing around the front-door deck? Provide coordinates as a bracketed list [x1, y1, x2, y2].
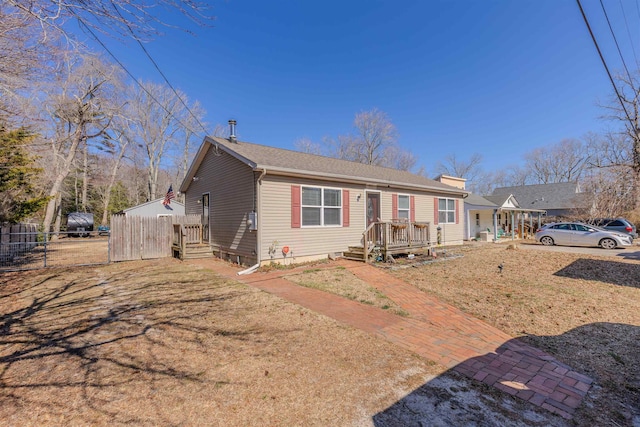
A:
[362, 220, 430, 262]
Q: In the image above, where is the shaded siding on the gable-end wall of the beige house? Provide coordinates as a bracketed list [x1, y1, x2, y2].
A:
[185, 149, 257, 261]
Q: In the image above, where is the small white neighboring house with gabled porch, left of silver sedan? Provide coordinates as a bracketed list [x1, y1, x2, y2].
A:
[464, 194, 545, 241]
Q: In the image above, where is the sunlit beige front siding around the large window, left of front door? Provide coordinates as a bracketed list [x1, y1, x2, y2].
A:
[259, 176, 365, 262]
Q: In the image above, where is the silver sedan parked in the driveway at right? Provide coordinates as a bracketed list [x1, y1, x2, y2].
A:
[536, 222, 633, 249]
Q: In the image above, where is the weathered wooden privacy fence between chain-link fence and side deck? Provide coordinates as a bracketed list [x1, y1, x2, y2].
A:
[110, 215, 201, 261]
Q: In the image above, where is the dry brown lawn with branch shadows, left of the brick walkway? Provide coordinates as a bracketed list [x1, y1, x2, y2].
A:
[0, 259, 443, 426]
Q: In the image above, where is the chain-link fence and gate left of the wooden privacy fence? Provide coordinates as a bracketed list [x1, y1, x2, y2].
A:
[0, 229, 110, 272]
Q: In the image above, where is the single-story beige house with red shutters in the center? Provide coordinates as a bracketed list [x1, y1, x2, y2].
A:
[180, 134, 467, 265]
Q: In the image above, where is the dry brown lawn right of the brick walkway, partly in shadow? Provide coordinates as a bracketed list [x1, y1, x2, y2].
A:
[391, 244, 640, 426]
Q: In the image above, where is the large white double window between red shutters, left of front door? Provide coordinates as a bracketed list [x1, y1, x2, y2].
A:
[302, 187, 342, 227]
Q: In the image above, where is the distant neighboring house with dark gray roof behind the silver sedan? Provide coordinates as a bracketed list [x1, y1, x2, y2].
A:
[493, 182, 584, 217]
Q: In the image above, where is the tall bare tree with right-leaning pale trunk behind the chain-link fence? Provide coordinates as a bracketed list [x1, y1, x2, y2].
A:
[43, 55, 119, 234]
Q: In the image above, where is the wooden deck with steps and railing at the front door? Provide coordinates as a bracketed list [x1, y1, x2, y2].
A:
[344, 220, 432, 262]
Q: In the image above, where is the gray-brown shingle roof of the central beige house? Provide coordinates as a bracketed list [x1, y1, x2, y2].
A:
[183, 137, 467, 194]
